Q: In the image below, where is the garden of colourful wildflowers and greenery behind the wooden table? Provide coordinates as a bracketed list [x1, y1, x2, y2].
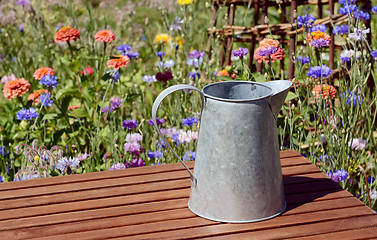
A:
[0, 0, 377, 210]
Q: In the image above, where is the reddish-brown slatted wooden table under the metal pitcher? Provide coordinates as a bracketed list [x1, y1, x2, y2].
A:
[0, 150, 377, 240]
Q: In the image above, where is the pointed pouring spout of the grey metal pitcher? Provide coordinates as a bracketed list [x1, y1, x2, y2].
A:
[263, 80, 292, 117]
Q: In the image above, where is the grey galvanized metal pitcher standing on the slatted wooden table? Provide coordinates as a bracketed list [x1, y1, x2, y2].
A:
[152, 80, 292, 223]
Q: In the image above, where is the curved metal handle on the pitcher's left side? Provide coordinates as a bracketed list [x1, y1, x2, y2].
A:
[152, 84, 205, 186]
